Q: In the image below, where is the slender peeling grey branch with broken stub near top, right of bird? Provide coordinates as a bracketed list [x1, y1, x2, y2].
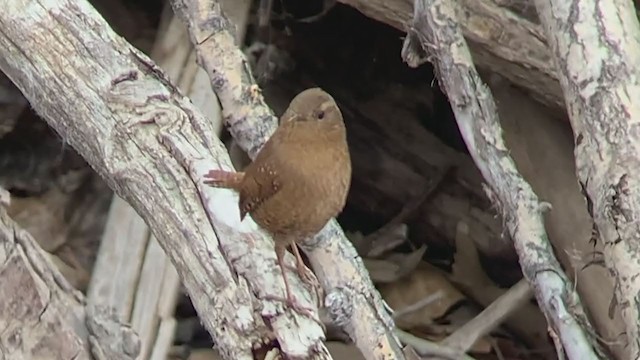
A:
[403, 0, 598, 359]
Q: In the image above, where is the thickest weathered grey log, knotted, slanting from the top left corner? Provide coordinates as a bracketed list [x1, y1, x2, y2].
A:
[0, 0, 329, 359]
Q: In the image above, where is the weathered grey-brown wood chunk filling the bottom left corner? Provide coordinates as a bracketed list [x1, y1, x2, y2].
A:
[0, 189, 140, 360]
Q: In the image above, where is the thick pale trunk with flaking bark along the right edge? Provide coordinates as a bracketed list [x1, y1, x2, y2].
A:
[535, 0, 640, 359]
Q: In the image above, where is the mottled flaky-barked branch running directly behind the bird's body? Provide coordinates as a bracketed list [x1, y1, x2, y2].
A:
[173, 0, 404, 359]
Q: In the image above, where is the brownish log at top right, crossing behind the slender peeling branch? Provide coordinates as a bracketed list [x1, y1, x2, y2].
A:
[339, 0, 564, 108]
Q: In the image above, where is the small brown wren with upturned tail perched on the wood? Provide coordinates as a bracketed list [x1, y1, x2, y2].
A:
[205, 88, 351, 312]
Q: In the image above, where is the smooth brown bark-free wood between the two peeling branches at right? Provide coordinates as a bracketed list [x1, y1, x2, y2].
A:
[490, 81, 628, 359]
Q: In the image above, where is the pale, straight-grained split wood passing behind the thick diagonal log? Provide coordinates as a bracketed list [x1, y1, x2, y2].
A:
[87, 0, 249, 360]
